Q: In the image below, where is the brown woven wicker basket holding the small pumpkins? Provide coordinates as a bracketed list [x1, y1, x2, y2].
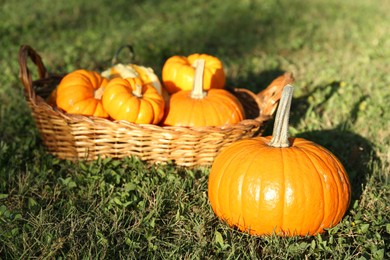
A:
[18, 45, 293, 167]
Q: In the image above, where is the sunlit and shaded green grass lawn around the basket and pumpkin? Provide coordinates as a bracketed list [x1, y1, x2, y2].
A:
[0, 0, 390, 259]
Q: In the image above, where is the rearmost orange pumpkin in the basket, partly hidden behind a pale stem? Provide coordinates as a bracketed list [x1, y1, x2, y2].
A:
[162, 53, 226, 94]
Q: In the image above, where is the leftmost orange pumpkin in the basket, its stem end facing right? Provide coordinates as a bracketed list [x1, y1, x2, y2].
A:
[56, 69, 108, 117]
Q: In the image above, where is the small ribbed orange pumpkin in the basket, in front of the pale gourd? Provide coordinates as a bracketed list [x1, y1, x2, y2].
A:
[102, 78, 165, 124]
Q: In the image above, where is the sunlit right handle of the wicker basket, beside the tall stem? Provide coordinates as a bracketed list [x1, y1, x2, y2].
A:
[257, 72, 294, 118]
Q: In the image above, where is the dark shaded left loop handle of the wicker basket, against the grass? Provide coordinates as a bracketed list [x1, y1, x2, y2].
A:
[18, 45, 48, 100]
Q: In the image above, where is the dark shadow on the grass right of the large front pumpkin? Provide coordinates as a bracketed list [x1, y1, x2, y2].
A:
[290, 81, 379, 201]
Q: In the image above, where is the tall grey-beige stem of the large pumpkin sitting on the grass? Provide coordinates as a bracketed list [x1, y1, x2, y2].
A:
[268, 85, 294, 148]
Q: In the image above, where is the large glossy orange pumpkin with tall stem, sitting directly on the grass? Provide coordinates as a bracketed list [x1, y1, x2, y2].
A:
[208, 85, 351, 236]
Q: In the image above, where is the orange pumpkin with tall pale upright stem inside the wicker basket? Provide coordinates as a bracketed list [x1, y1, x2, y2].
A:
[162, 60, 244, 127]
